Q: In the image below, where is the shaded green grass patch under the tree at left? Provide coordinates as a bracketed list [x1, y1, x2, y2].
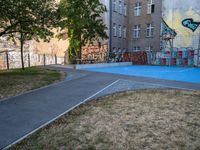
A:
[0, 67, 65, 99]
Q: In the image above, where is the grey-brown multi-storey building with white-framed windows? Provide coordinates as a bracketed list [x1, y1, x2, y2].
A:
[85, 0, 162, 61]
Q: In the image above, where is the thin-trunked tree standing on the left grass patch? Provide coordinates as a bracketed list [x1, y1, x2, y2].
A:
[0, 0, 57, 69]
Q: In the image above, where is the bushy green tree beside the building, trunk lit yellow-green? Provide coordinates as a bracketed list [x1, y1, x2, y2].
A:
[59, 0, 108, 62]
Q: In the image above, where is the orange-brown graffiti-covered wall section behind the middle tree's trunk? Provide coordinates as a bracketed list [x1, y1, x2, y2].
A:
[82, 43, 108, 62]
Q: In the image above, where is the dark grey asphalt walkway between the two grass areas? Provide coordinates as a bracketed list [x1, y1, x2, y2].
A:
[0, 66, 200, 149]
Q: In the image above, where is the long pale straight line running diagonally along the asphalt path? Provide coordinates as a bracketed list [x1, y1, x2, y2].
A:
[3, 80, 120, 150]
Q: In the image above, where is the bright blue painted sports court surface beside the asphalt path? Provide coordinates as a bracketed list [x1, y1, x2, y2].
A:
[84, 65, 200, 83]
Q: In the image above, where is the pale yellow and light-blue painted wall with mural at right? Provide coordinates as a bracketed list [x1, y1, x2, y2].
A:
[162, 0, 200, 49]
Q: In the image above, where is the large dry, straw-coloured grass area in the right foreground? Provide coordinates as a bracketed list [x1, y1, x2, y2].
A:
[10, 90, 200, 150]
